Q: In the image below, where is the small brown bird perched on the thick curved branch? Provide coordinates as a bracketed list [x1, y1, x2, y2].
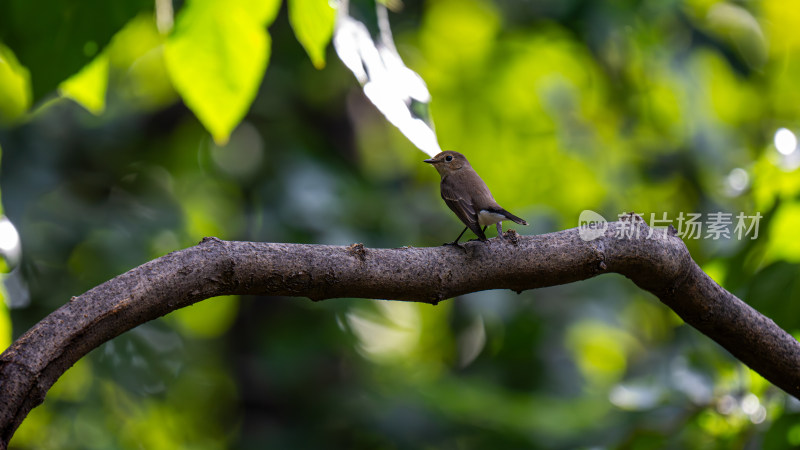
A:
[425, 150, 528, 245]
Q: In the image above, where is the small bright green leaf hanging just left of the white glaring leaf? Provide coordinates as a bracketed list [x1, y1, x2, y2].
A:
[289, 0, 336, 69]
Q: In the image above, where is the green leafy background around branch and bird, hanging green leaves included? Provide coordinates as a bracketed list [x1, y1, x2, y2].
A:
[0, 0, 800, 449]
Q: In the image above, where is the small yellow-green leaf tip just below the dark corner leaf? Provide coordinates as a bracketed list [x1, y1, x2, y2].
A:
[59, 53, 108, 115]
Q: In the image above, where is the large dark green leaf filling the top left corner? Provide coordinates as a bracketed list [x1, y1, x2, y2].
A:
[0, 0, 153, 102]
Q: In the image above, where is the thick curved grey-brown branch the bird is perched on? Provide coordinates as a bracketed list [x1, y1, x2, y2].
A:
[0, 216, 800, 448]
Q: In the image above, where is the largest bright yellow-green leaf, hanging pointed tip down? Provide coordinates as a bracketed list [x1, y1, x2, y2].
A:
[164, 0, 270, 144]
